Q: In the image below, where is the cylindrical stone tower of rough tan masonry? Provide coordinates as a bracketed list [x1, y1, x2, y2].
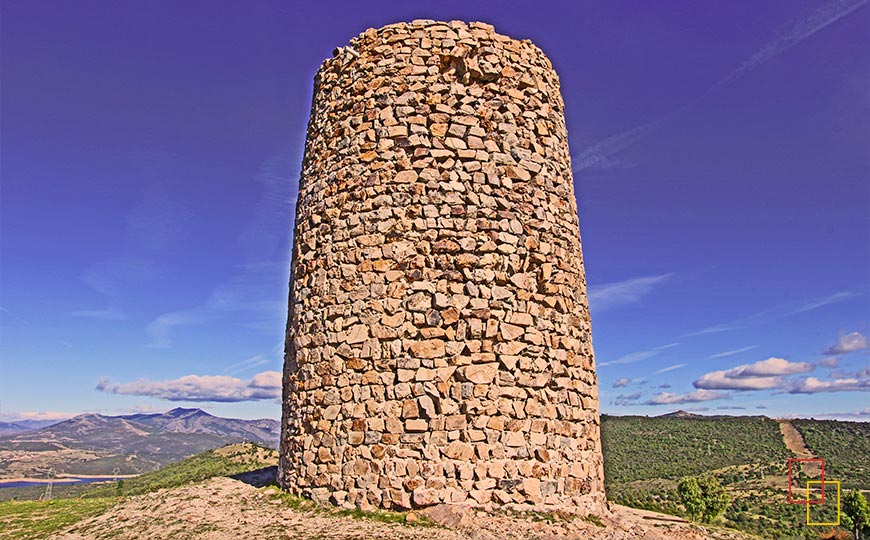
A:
[279, 20, 605, 512]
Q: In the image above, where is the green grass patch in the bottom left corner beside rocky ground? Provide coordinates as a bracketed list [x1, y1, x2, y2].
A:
[0, 497, 117, 540]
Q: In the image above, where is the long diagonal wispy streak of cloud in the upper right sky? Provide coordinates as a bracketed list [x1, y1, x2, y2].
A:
[572, 0, 867, 174]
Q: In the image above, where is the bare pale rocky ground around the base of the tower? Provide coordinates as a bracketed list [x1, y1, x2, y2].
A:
[51, 478, 753, 540]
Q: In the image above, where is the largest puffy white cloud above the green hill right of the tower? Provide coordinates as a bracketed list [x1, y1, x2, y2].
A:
[692, 358, 815, 390]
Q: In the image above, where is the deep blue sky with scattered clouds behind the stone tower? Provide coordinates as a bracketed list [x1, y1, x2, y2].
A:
[0, 0, 870, 419]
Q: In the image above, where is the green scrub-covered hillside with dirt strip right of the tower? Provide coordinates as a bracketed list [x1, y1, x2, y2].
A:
[601, 411, 870, 540]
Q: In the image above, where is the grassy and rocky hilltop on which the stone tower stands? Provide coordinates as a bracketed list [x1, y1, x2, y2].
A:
[0, 444, 751, 540]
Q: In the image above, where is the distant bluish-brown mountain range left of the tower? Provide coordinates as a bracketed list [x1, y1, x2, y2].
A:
[0, 408, 281, 478]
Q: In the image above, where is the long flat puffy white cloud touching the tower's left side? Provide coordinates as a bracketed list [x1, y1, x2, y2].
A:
[96, 371, 281, 402]
